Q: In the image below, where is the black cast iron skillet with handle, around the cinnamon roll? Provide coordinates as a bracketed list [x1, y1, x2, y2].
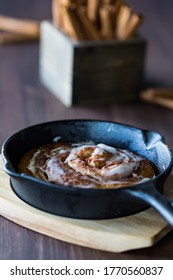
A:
[2, 120, 173, 226]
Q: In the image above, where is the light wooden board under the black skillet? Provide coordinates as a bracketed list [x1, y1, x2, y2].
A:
[0, 157, 173, 252]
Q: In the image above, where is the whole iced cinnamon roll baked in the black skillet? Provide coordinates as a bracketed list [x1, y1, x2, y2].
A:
[19, 142, 154, 189]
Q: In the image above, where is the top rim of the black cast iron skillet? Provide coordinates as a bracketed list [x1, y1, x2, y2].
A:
[1, 118, 173, 193]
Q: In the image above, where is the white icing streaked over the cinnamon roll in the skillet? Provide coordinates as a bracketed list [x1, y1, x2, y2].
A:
[29, 142, 154, 188]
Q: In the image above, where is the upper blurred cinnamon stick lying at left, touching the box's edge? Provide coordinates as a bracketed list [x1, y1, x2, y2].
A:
[0, 15, 40, 39]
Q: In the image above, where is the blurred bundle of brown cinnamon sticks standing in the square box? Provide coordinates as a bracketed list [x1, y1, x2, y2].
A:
[52, 0, 143, 41]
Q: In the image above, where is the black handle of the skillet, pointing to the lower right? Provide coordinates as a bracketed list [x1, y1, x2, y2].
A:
[127, 184, 173, 227]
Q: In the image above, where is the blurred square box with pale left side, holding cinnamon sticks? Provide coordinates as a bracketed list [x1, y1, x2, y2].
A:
[39, 21, 146, 106]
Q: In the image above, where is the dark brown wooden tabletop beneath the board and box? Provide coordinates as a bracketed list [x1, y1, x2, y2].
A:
[0, 0, 173, 259]
